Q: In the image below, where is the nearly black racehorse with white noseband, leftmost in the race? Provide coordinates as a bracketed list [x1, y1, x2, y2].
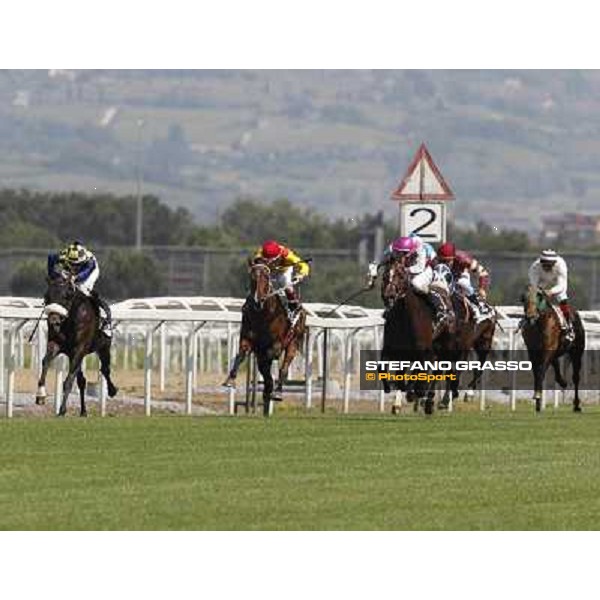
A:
[35, 272, 118, 417]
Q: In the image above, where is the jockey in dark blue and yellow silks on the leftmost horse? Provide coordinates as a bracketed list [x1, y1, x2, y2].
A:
[48, 241, 112, 336]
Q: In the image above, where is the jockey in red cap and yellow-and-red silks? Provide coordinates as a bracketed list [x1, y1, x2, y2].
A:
[254, 240, 310, 320]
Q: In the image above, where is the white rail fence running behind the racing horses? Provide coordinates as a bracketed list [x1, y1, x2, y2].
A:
[0, 297, 600, 417]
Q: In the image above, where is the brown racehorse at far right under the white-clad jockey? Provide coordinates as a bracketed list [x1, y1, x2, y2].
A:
[521, 285, 585, 412]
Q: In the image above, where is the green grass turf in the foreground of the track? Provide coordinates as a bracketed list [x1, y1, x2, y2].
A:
[0, 407, 600, 530]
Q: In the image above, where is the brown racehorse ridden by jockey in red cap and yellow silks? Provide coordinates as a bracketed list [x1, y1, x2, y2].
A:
[223, 260, 306, 417]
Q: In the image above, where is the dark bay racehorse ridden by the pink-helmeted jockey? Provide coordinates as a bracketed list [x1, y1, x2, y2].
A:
[381, 257, 453, 414]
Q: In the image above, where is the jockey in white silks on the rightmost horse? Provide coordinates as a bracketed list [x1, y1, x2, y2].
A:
[529, 250, 575, 341]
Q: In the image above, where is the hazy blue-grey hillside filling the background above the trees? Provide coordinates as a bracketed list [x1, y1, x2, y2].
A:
[0, 71, 600, 230]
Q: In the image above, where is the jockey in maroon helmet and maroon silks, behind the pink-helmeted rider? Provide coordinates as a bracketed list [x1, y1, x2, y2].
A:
[438, 242, 490, 323]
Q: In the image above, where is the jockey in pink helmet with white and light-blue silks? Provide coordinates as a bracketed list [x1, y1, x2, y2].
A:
[368, 234, 449, 330]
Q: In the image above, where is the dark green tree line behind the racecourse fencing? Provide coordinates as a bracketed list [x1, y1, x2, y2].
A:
[0, 190, 572, 306]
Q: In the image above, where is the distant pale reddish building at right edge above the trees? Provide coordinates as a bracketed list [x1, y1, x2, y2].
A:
[540, 213, 600, 248]
